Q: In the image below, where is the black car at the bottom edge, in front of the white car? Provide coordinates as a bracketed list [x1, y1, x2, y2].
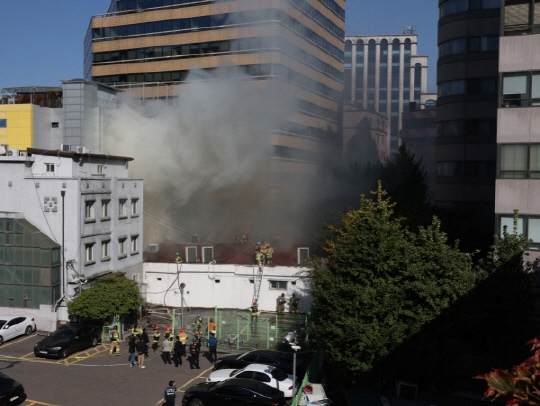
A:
[182, 378, 286, 406]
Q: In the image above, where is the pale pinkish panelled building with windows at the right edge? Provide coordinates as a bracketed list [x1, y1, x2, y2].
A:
[495, 0, 540, 261]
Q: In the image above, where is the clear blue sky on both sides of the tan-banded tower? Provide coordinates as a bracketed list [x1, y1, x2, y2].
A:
[0, 0, 437, 91]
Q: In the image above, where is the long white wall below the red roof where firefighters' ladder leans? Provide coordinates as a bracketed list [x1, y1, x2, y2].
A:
[140, 262, 312, 312]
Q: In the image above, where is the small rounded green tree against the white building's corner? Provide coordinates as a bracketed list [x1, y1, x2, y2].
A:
[68, 273, 142, 320]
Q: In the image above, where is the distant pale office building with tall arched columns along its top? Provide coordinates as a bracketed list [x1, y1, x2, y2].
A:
[343, 32, 428, 152]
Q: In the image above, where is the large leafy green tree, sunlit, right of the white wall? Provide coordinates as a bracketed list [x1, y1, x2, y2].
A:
[312, 182, 475, 382]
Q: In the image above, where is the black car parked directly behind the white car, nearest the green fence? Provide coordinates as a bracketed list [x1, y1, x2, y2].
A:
[214, 350, 306, 376]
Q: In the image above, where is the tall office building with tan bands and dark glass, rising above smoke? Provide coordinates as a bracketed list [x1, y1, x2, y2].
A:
[84, 0, 345, 177]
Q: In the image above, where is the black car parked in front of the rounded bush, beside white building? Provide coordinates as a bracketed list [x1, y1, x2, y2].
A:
[34, 324, 101, 358]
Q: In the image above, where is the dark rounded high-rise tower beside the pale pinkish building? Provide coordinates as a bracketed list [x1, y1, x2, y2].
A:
[434, 0, 500, 213]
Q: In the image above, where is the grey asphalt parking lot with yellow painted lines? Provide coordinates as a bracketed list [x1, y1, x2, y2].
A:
[0, 334, 219, 406]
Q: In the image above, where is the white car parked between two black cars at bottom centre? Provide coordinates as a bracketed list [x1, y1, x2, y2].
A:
[206, 364, 293, 398]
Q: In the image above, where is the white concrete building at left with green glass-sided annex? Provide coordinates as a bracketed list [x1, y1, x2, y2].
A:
[0, 148, 144, 330]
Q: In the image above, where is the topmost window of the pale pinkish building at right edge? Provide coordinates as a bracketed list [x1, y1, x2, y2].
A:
[504, 0, 540, 35]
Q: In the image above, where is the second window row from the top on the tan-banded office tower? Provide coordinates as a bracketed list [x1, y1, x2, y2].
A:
[92, 9, 343, 60]
